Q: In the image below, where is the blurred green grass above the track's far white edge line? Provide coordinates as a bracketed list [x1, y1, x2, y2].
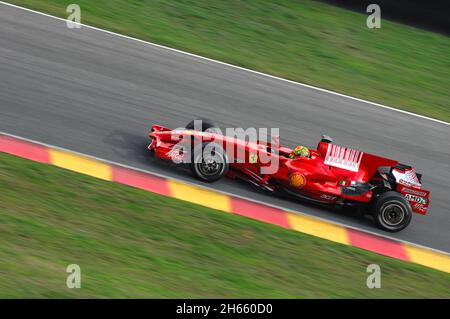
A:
[8, 0, 450, 121]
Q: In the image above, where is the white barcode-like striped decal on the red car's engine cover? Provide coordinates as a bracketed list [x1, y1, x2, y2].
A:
[324, 144, 364, 172]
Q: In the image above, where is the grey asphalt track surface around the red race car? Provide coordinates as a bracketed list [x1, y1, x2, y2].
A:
[0, 4, 450, 252]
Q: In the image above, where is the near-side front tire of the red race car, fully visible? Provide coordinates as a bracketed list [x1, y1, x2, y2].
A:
[190, 142, 229, 183]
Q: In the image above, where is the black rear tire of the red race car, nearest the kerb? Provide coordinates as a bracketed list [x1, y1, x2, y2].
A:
[373, 191, 412, 232]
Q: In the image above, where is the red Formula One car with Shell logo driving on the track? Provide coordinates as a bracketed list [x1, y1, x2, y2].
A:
[148, 120, 430, 232]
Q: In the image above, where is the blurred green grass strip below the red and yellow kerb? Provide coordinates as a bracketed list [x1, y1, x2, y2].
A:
[0, 153, 450, 298]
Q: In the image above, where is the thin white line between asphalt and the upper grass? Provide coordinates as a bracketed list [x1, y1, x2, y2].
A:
[0, 1, 450, 125]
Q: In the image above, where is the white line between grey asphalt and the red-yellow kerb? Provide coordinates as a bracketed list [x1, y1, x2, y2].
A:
[0, 131, 450, 256]
